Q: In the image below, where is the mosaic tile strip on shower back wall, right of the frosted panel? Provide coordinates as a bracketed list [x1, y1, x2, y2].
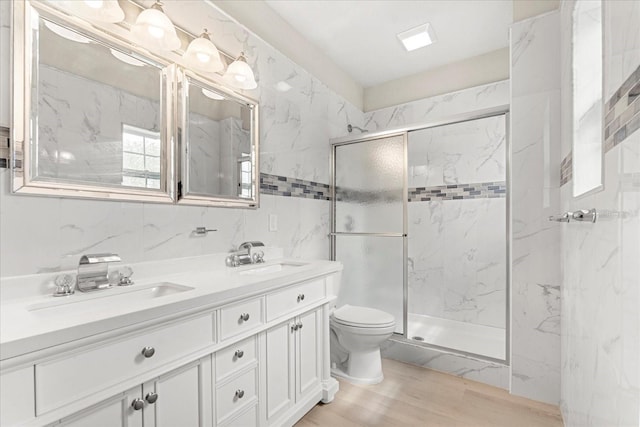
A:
[409, 181, 507, 202]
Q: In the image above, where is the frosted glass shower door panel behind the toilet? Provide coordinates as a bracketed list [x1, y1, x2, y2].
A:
[332, 134, 406, 334]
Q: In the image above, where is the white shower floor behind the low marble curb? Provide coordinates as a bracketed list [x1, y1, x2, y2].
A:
[407, 313, 506, 360]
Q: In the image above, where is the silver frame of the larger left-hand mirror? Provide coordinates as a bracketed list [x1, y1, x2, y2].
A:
[11, 1, 176, 203]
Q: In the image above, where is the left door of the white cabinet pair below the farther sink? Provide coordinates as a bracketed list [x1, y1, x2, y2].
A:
[265, 321, 296, 424]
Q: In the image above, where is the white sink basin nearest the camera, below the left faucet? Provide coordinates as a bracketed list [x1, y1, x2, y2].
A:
[27, 282, 193, 314]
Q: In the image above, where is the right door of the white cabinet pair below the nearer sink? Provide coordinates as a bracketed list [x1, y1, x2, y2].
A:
[142, 356, 213, 427]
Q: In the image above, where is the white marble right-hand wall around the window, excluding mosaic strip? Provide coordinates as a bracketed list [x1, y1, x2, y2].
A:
[556, 1, 640, 427]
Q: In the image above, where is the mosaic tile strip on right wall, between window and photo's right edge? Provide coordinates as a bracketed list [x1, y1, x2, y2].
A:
[604, 66, 640, 153]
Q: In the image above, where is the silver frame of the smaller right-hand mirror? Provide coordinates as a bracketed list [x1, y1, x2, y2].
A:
[175, 67, 260, 209]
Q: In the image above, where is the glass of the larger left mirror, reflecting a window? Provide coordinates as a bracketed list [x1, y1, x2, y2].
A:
[30, 13, 164, 190]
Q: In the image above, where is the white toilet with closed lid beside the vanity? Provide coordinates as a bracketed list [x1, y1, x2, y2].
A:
[330, 304, 396, 384]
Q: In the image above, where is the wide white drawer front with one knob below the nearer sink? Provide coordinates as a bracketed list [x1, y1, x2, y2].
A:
[35, 313, 214, 415]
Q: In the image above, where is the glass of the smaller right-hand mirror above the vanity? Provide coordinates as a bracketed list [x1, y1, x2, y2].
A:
[183, 76, 255, 199]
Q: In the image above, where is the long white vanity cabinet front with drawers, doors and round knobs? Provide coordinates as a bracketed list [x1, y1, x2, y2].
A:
[0, 273, 337, 427]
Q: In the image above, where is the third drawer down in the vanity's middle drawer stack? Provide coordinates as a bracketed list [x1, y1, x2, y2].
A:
[216, 369, 256, 423]
